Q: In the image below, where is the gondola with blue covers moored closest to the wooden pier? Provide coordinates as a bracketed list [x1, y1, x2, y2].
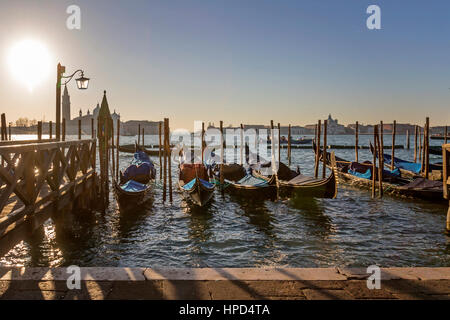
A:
[113, 145, 156, 211]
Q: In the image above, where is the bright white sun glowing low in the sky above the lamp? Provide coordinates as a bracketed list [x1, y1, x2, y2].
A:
[8, 40, 51, 91]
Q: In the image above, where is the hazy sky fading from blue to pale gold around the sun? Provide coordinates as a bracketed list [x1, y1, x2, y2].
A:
[0, 0, 450, 129]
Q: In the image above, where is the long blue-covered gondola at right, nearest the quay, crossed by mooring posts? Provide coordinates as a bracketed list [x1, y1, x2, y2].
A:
[313, 144, 444, 201]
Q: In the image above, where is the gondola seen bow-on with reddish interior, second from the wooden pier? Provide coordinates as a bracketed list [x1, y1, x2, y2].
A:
[178, 163, 215, 207]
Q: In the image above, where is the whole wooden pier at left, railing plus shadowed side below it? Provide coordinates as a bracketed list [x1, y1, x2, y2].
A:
[0, 139, 96, 255]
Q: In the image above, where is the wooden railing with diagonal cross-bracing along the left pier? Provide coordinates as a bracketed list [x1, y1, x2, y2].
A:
[0, 139, 96, 236]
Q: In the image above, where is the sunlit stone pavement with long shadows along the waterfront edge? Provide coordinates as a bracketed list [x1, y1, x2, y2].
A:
[0, 267, 450, 300]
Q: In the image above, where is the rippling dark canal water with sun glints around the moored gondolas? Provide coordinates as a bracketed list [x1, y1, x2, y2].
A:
[0, 135, 450, 267]
